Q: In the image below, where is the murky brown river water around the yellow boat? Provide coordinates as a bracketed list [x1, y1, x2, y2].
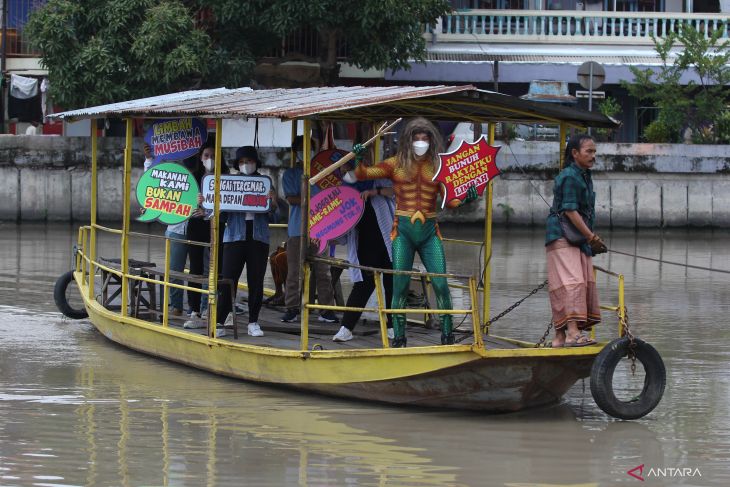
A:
[0, 224, 730, 486]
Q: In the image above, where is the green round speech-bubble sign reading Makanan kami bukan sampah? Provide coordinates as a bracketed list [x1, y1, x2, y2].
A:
[137, 162, 199, 225]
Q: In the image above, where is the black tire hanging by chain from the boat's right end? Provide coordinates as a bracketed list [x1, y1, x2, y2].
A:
[591, 337, 667, 419]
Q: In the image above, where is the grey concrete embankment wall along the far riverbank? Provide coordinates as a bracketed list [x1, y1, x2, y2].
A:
[0, 136, 730, 228]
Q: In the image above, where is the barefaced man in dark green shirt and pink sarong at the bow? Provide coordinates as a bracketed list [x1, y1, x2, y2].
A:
[545, 135, 607, 347]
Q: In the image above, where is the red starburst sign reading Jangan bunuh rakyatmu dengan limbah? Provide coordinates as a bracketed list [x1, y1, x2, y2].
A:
[433, 136, 500, 208]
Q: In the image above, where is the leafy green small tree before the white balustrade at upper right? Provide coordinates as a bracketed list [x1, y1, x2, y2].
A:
[622, 23, 730, 143]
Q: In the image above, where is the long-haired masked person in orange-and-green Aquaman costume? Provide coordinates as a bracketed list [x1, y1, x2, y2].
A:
[346, 118, 477, 348]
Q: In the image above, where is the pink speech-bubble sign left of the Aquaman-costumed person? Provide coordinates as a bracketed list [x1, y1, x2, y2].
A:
[309, 186, 364, 253]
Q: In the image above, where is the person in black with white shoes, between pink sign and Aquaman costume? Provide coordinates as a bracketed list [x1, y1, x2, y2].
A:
[332, 172, 395, 342]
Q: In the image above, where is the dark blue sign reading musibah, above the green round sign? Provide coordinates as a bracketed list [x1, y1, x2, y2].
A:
[144, 118, 208, 162]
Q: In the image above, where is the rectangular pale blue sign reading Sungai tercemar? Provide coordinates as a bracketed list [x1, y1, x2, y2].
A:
[202, 174, 271, 213]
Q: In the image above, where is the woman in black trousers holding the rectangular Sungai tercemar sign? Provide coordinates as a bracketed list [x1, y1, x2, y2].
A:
[217, 145, 278, 337]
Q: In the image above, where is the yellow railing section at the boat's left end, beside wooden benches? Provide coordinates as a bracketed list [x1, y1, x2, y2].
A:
[75, 224, 220, 327]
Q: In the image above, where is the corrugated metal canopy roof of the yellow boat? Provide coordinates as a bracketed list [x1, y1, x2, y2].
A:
[52, 85, 619, 128]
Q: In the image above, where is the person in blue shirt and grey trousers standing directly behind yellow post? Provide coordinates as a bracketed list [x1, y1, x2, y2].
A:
[281, 136, 339, 323]
